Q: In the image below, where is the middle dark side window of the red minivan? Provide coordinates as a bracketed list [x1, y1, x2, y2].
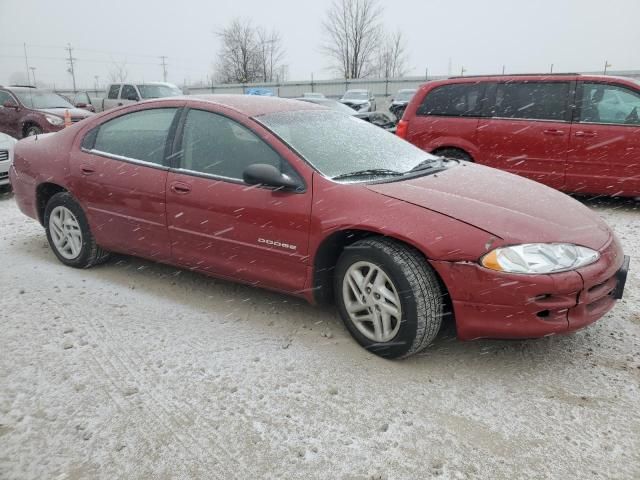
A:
[492, 82, 569, 121]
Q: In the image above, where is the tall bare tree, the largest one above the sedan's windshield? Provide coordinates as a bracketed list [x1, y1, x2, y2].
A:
[322, 0, 382, 79]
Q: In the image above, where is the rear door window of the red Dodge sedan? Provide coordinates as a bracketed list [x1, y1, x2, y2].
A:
[92, 108, 177, 165]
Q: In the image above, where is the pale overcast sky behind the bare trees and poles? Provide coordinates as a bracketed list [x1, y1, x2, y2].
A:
[0, 0, 640, 88]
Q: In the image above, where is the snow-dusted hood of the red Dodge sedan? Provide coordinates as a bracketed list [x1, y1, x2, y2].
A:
[367, 162, 611, 250]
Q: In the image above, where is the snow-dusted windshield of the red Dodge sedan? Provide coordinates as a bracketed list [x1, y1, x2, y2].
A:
[257, 110, 438, 181]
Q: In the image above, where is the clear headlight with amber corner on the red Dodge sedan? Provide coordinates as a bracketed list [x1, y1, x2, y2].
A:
[480, 243, 600, 274]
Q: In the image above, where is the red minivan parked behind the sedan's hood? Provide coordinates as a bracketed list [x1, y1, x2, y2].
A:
[397, 74, 640, 196]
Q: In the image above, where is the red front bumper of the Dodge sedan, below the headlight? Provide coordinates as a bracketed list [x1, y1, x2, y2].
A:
[432, 235, 629, 340]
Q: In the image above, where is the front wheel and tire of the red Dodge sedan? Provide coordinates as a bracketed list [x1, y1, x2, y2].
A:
[334, 237, 444, 358]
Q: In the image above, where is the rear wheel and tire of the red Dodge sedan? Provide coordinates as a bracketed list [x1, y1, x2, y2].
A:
[44, 192, 109, 268]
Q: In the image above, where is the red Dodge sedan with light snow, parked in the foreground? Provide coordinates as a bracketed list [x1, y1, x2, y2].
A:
[10, 95, 628, 358]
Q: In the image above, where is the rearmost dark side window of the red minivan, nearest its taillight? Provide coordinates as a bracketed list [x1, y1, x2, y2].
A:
[417, 83, 485, 117]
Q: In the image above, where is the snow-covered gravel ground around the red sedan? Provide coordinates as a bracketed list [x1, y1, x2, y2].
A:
[0, 195, 640, 480]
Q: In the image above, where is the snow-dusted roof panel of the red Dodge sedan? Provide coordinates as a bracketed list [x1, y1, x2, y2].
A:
[184, 94, 325, 117]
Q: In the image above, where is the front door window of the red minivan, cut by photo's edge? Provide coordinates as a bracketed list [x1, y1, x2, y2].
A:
[578, 82, 640, 125]
